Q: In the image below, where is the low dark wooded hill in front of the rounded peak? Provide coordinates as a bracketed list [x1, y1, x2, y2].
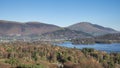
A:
[42, 28, 92, 40]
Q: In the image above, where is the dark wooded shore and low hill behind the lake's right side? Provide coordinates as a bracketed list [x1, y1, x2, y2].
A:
[71, 33, 120, 44]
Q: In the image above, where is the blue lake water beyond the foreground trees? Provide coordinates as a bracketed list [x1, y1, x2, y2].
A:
[57, 42, 120, 53]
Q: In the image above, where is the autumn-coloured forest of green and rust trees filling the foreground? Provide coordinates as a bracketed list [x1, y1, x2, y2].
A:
[0, 41, 120, 68]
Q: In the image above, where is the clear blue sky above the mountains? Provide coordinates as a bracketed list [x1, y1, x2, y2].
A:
[0, 0, 120, 31]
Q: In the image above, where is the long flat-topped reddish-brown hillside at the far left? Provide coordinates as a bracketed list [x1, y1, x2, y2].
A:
[0, 20, 60, 35]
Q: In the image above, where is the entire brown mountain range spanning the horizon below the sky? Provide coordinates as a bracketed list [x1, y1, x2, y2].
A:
[0, 20, 118, 39]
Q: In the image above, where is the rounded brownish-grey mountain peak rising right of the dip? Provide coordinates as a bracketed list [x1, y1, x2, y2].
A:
[68, 22, 117, 36]
